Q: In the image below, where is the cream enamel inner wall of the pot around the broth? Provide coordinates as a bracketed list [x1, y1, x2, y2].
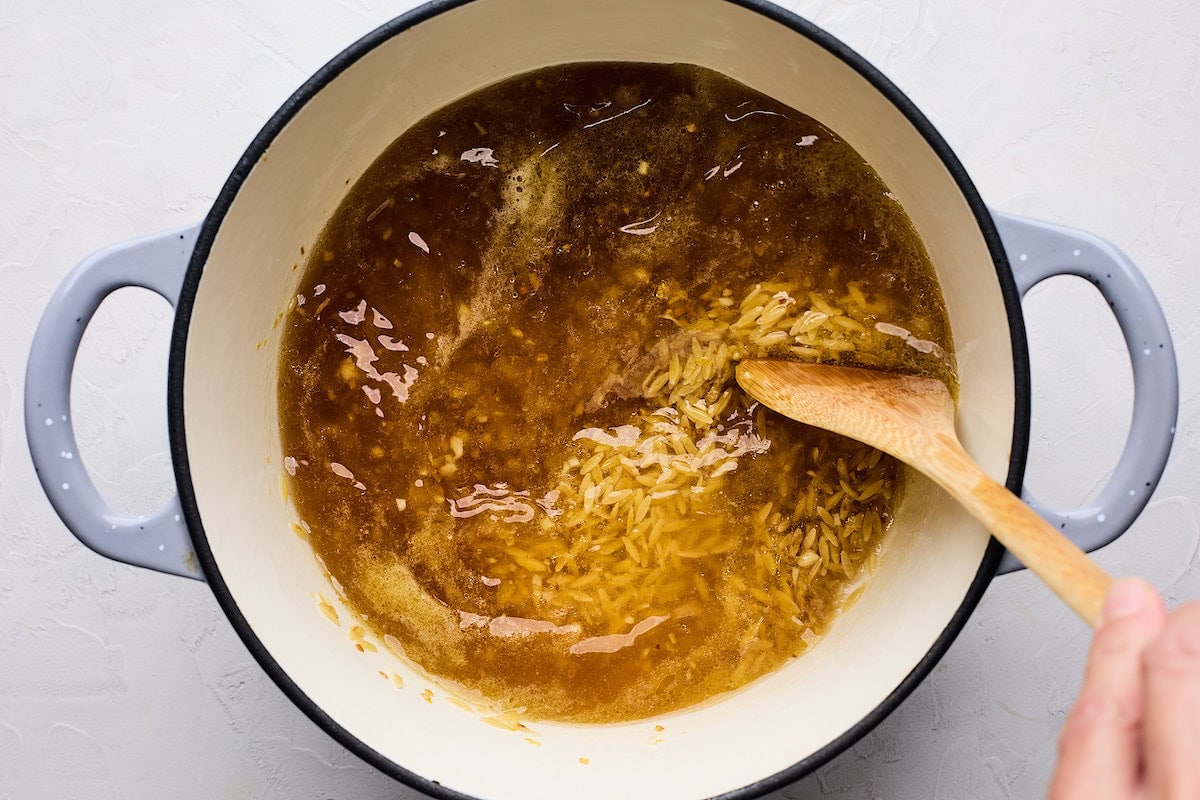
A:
[185, 0, 1014, 800]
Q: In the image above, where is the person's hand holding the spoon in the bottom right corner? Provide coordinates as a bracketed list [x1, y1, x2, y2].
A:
[1050, 578, 1200, 800]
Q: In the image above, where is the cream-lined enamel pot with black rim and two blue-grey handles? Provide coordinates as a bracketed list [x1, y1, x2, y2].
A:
[25, 0, 1178, 800]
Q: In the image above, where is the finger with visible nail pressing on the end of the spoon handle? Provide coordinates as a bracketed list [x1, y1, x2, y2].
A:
[1050, 579, 1166, 800]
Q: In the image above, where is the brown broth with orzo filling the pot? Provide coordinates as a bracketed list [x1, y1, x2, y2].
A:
[280, 64, 954, 722]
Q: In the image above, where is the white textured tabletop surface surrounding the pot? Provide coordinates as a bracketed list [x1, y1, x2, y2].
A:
[0, 0, 1200, 800]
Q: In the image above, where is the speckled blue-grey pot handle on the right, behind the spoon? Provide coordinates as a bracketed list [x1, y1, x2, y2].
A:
[992, 211, 1180, 573]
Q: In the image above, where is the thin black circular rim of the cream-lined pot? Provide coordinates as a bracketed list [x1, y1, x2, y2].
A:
[167, 0, 1030, 800]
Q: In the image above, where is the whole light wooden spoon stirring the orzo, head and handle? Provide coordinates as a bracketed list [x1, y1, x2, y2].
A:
[737, 360, 1112, 627]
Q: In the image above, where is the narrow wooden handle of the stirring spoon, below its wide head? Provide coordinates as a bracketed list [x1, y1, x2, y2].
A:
[925, 435, 1112, 627]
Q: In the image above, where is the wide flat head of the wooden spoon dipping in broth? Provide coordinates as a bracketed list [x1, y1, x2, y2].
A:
[737, 359, 954, 463]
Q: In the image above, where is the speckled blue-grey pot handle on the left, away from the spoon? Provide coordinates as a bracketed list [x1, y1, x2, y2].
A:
[25, 225, 204, 581]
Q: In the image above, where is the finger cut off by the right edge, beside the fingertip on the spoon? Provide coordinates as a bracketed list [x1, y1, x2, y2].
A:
[1144, 603, 1200, 800]
